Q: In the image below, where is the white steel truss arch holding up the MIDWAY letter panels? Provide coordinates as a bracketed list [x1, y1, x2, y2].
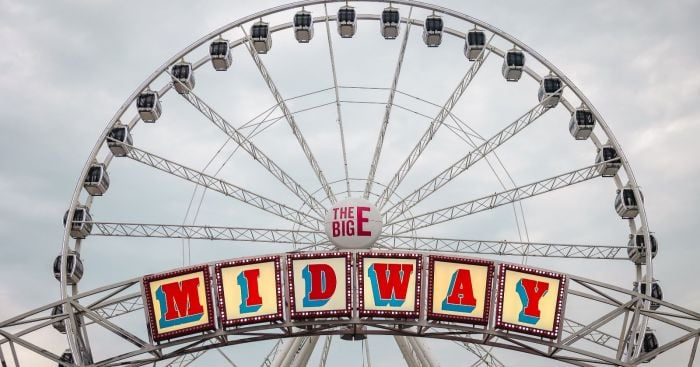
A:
[0, 275, 700, 366]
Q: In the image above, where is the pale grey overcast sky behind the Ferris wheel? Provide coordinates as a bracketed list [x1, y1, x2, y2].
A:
[0, 0, 700, 366]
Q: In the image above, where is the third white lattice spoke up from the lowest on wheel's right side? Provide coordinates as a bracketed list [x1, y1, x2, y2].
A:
[385, 96, 550, 221]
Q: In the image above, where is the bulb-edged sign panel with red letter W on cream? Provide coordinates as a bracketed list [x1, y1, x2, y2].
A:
[357, 252, 422, 318]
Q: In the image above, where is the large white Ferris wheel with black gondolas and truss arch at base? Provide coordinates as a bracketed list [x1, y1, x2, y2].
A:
[0, 0, 700, 366]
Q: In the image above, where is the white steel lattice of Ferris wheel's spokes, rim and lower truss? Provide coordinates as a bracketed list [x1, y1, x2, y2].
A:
[0, 0, 700, 366]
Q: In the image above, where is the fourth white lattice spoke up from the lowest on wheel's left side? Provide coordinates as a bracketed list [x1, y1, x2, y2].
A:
[241, 27, 336, 203]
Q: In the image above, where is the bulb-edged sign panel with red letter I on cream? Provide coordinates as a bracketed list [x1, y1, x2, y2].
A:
[216, 256, 282, 326]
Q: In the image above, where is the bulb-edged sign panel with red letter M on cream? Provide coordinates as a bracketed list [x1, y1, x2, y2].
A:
[142, 265, 215, 341]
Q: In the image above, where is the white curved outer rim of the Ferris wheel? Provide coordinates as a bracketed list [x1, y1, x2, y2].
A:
[60, 0, 653, 366]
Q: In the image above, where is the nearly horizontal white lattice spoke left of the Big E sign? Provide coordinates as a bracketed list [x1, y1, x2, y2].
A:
[84, 222, 328, 245]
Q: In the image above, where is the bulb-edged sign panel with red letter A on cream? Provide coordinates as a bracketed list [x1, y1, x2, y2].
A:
[427, 256, 494, 325]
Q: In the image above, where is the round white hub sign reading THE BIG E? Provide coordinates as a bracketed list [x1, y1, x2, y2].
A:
[325, 198, 382, 249]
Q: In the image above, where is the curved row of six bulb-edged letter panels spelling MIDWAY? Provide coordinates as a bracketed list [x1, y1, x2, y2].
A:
[142, 251, 567, 342]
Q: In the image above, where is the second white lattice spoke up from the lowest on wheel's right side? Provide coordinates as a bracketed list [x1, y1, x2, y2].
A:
[385, 161, 608, 235]
